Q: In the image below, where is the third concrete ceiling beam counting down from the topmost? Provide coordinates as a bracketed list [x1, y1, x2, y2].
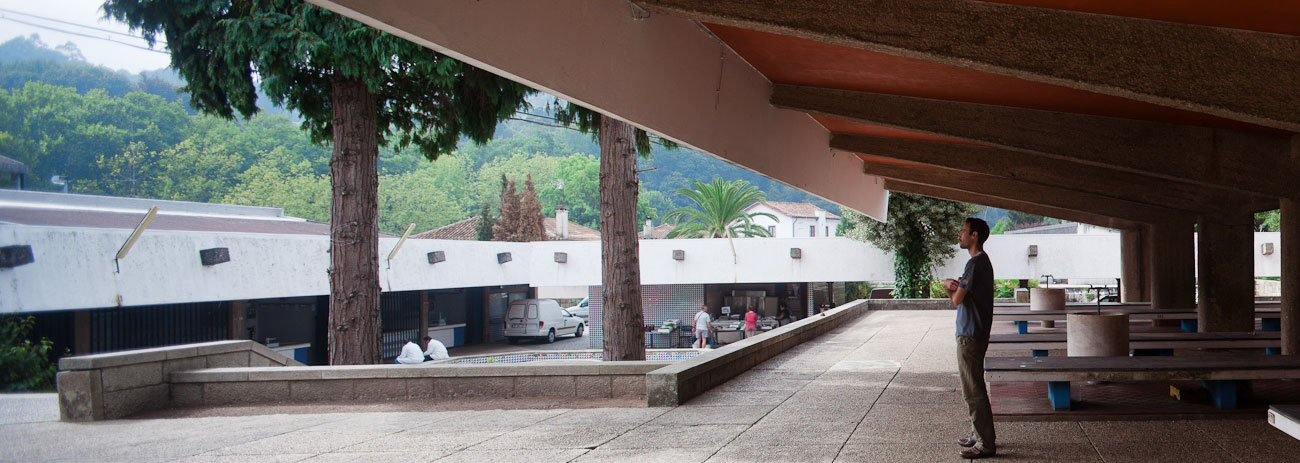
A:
[831, 134, 1275, 212]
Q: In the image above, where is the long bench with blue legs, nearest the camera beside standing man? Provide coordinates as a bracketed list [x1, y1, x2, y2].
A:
[984, 355, 1300, 410]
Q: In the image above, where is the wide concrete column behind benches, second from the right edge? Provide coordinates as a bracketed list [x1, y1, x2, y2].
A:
[1196, 212, 1255, 333]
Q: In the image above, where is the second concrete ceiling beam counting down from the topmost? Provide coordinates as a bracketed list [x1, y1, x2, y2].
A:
[772, 85, 1300, 198]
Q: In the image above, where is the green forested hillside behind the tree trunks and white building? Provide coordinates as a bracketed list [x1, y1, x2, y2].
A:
[0, 36, 839, 233]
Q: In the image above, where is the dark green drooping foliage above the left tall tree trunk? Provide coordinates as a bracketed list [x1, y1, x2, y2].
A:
[104, 0, 532, 160]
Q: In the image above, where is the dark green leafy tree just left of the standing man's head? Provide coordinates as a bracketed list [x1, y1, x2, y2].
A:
[842, 192, 978, 299]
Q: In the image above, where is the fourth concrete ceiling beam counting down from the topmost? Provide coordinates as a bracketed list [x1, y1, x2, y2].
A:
[863, 161, 1195, 222]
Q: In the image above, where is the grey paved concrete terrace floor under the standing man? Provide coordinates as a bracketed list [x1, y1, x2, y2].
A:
[0, 311, 1300, 463]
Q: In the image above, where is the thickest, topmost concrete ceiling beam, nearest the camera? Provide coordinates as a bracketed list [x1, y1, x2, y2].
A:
[633, 0, 1300, 131]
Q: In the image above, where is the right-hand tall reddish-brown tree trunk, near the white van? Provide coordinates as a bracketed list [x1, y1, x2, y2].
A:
[601, 116, 646, 360]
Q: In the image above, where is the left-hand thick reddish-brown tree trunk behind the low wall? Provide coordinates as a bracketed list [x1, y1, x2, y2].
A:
[329, 75, 381, 365]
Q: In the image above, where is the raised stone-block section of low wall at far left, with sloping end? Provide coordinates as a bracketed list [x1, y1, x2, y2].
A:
[56, 341, 302, 421]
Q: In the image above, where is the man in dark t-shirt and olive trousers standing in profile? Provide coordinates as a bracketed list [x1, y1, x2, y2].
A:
[944, 217, 997, 459]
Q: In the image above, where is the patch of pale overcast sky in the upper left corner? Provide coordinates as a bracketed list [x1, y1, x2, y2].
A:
[0, 0, 168, 73]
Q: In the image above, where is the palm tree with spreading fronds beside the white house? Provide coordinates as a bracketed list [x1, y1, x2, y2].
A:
[663, 178, 776, 238]
